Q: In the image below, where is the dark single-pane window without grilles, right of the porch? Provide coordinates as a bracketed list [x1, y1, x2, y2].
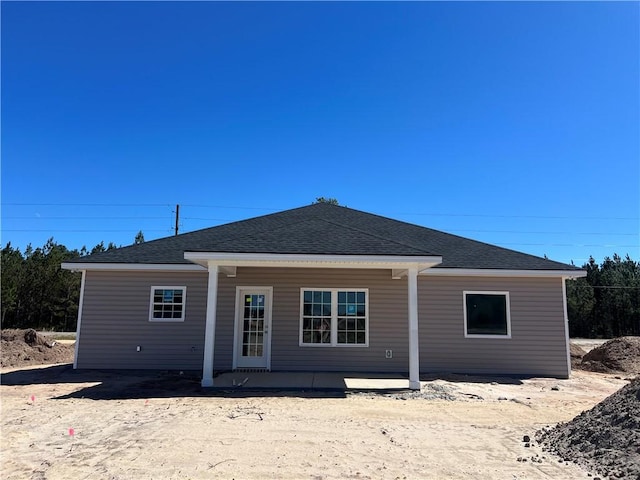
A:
[463, 292, 511, 338]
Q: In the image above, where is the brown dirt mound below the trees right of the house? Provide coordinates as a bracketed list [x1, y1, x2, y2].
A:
[577, 337, 640, 374]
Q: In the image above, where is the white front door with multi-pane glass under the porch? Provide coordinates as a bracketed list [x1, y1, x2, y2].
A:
[233, 287, 272, 370]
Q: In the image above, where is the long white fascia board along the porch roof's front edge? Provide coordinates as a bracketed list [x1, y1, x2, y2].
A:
[184, 252, 442, 270]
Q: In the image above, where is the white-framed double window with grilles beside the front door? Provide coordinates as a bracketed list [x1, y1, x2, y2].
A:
[300, 289, 369, 347]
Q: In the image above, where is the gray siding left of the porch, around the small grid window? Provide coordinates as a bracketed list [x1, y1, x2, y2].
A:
[78, 271, 207, 370]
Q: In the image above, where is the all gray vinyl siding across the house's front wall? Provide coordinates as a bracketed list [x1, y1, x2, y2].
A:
[78, 268, 568, 377]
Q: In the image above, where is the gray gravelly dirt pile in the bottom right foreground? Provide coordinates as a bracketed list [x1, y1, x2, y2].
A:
[536, 377, 640, 479]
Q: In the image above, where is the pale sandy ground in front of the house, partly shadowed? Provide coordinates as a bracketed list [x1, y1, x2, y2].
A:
[0, 365, 628, 480]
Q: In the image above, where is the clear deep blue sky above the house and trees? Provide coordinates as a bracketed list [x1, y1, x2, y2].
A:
[1, 2, 640, 264]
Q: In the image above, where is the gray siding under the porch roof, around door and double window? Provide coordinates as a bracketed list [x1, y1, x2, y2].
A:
[214, 268, 409, 372]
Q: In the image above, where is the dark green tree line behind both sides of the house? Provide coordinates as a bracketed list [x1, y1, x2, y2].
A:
[0, 237, 640, 338]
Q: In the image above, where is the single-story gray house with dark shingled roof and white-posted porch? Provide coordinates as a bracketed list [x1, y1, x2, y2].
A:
[62, 203, 585, 388]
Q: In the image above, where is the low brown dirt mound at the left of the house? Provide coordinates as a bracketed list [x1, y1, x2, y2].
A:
[0, 328, 74, 368]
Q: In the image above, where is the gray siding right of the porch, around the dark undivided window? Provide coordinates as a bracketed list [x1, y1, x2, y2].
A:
[418, 276, 569, 378]
